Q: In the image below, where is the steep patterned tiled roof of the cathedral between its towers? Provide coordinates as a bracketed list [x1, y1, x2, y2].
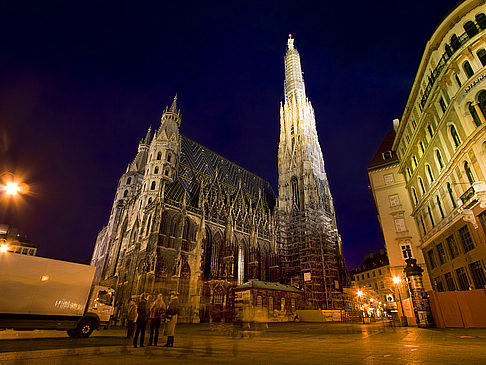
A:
[165, 136, 275, 209]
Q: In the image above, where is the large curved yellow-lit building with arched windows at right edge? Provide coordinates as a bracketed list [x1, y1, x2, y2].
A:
[391, 0, 486, 291]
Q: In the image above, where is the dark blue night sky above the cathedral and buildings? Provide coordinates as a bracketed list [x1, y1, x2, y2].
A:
[0, 0, 457, 268]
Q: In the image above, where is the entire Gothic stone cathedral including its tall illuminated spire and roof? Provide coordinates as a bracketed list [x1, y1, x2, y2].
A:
[91, 40, 345, 322]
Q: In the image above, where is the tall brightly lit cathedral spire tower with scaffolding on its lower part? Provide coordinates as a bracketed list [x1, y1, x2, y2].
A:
[278, 36, 345, 309]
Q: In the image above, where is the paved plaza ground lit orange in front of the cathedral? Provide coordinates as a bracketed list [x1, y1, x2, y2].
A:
[0, 322, 486, 365]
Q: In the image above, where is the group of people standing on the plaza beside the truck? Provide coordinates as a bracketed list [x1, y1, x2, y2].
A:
[127, 292, 179, 347]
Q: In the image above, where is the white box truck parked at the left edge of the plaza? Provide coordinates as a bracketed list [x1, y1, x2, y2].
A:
[0, 252, 114, 337]
